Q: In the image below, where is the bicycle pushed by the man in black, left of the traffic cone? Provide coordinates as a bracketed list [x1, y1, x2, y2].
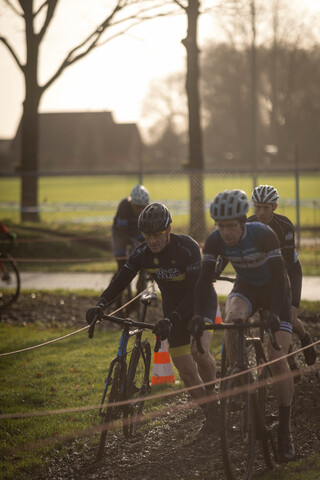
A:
[88, 292, 160, 460]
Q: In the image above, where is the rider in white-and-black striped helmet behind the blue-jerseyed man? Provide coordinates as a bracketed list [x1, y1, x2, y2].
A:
[247, 185, 317, 369]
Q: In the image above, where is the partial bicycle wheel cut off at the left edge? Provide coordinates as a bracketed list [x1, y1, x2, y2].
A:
[0, 253, 20, 310]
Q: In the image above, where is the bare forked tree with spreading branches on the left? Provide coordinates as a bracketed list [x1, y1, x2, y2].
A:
[0, 0, 174, 221]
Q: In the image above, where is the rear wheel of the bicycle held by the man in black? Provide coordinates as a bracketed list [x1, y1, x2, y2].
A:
[123, 340, 151, 438]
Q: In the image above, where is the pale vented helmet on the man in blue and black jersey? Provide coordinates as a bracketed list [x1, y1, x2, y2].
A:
[210, 190, 249, 220]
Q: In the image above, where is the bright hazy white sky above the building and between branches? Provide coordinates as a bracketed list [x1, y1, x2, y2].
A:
[0, 0, 320, 138]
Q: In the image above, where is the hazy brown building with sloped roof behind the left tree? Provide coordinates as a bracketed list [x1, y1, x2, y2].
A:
[7, 112, 143, 172]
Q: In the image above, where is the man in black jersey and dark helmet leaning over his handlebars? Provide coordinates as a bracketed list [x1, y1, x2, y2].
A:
[86, 203, 217, 433]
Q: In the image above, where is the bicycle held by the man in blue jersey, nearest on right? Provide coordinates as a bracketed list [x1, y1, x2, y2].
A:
[196, 311, 280, 480]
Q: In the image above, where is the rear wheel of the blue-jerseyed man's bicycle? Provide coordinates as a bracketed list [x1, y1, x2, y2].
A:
[257, 358, 279, 469]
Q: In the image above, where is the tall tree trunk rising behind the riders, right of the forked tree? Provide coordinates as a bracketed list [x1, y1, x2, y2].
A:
[182, 0, 206, 240]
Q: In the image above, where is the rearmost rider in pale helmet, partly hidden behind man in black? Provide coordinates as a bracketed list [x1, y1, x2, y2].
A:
[112, 185, 150, 270]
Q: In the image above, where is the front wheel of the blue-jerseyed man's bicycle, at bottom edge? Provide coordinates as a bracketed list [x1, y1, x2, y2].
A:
[220, 368, 255, 480]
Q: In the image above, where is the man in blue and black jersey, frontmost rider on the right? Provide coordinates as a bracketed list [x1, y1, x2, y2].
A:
[189, 190, 295, 462]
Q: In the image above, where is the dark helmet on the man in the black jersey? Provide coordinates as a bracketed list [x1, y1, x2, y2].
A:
[138, 203, 172, 233]
